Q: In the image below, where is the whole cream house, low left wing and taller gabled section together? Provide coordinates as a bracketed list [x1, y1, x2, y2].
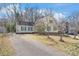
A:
[16, 16, 58, 33]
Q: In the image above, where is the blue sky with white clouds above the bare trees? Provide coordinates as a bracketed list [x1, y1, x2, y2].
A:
[0, 3, 79, 17]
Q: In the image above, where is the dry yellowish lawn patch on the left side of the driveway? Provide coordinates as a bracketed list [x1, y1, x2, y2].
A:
[0, 33, 14, 56]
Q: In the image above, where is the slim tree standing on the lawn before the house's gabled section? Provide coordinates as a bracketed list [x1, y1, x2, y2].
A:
[44, 9, 55, 38]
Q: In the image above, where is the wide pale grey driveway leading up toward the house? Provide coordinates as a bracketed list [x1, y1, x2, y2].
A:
[10, 34, 65, 56]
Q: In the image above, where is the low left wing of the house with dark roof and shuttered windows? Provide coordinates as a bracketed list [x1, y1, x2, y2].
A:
[16, 21, 34, 33]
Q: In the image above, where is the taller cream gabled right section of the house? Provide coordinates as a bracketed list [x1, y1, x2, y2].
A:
[36, 16, 58, 33]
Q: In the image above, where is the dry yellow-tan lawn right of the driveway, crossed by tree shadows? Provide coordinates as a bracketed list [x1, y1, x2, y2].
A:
[20, 34, 79, 56]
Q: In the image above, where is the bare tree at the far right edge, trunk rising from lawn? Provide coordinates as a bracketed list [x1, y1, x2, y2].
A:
[69, 12, 79, 39]
